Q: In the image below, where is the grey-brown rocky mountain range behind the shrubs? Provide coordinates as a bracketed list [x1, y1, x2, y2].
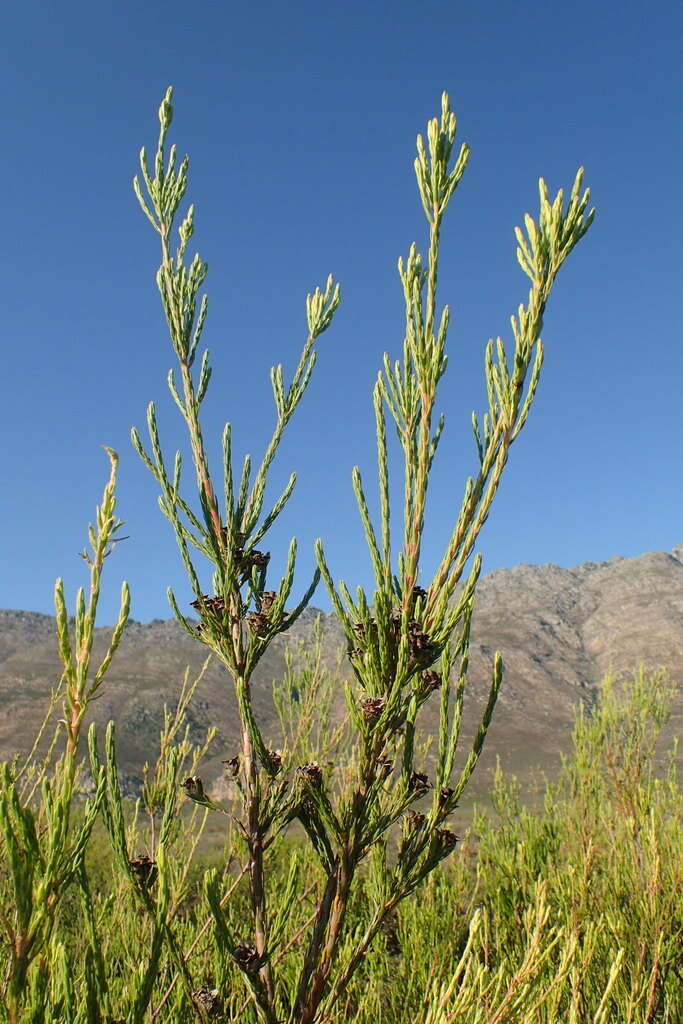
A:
[0, 545, 683, 795]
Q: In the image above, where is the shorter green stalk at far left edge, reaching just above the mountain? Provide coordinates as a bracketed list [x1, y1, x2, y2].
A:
[0, 449, 130, 1024]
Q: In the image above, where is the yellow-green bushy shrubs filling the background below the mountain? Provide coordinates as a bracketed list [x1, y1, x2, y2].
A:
[0, 669, 683, 1024]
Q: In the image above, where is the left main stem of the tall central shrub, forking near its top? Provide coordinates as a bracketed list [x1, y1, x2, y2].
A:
[132, 88, 339, 1024]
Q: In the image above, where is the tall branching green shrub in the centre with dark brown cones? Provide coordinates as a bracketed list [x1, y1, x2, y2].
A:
[126, 88, 593, 1024]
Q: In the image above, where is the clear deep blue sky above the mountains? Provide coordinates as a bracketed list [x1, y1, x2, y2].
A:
[0, 0, 683, 625]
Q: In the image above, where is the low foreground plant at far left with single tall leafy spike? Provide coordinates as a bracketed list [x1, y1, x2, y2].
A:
[0, 449, 130, 1024]
